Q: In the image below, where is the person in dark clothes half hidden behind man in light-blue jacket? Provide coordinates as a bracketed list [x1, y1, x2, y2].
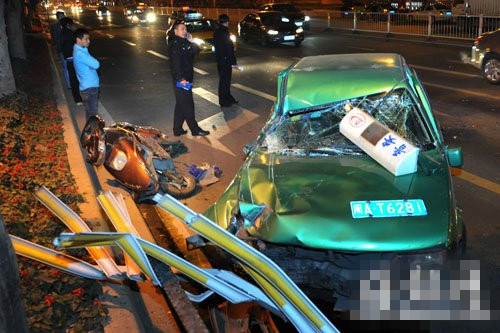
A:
[60, 17, 82, 105]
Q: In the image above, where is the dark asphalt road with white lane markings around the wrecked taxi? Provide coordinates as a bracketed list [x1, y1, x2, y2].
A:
[52, 6, 500, 330]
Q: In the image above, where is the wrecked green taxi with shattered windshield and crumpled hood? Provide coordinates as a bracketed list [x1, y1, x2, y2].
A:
[205, 54, 466, 304]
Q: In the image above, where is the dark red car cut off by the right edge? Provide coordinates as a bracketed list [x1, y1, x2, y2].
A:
[471, 29, 500, 84]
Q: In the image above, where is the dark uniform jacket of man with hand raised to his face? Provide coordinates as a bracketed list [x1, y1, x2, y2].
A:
[168, 35, 200, 82]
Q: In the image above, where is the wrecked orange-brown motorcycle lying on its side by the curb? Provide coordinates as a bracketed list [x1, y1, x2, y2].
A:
[80, 116, 196, 202]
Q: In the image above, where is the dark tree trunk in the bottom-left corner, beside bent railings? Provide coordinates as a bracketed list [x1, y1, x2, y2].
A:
[0, 216, 28, 333]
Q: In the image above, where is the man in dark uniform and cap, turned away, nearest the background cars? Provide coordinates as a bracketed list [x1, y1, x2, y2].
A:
[214, 14, 238, 107]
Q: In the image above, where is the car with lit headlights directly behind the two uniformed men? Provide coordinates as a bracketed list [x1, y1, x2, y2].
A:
[166, 18, 238, 54]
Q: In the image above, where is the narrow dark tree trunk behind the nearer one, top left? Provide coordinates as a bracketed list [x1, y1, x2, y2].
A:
[7, 0, 26, 59]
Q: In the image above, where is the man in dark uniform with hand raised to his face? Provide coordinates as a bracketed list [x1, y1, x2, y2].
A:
[168, 21, 210, 136]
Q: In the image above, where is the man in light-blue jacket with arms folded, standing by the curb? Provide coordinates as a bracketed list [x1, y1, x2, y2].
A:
[73, 29, 100, 119]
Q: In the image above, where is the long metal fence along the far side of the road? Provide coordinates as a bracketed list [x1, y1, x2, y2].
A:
[155, 7, 500, 40]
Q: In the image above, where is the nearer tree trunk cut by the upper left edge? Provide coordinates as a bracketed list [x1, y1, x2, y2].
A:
[0, 0, 16, 97]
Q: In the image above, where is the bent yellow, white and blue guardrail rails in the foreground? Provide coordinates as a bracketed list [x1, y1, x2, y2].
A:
[10, 187, 338, 332]
